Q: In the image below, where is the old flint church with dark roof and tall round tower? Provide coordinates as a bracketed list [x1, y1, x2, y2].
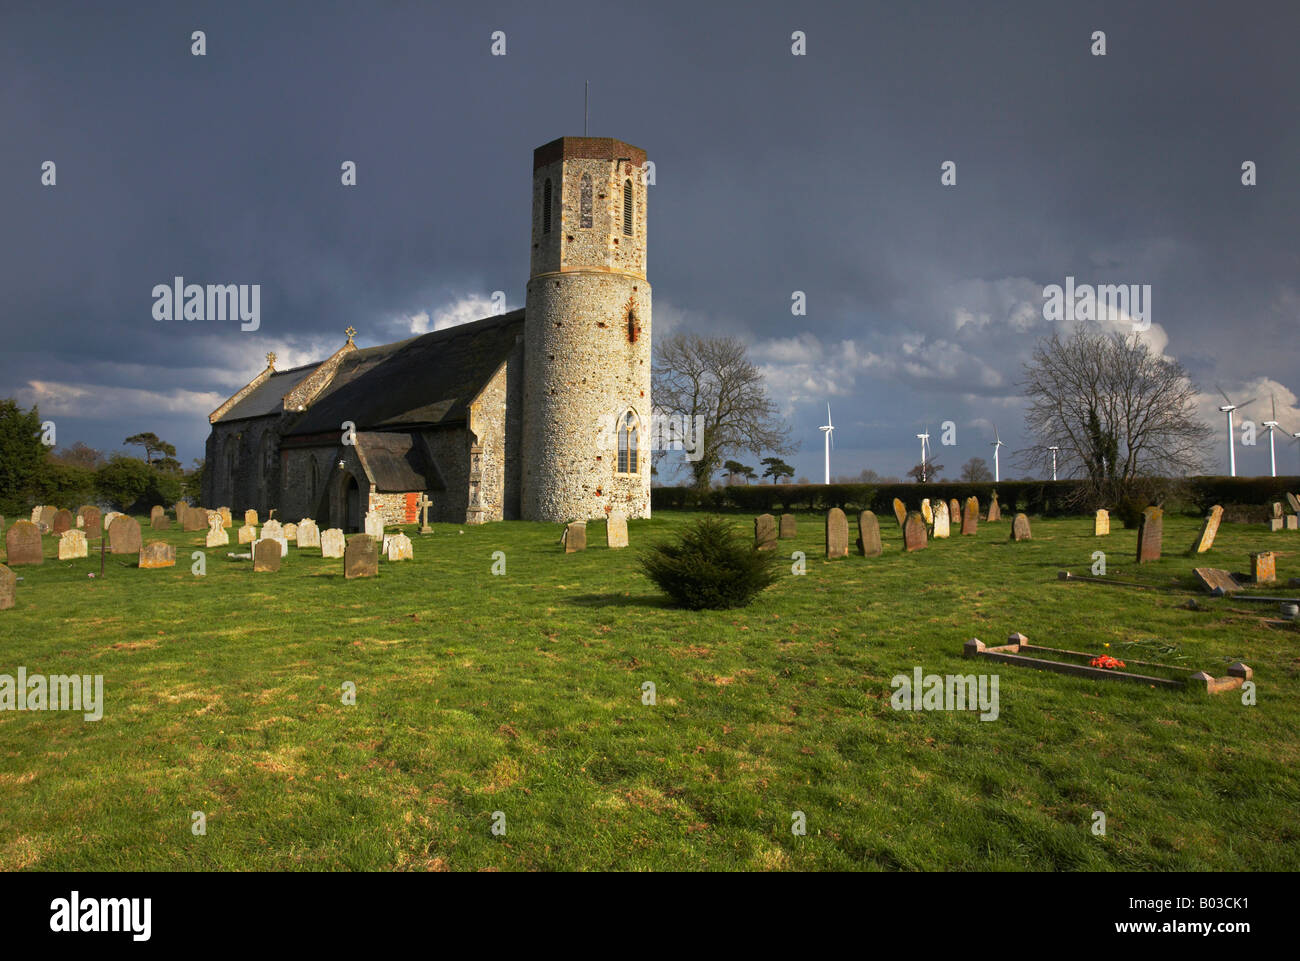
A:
[203, 137, 651, 532]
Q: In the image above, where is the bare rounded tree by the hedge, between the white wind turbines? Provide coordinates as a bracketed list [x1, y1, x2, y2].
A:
[1017, 324, 1212, 502]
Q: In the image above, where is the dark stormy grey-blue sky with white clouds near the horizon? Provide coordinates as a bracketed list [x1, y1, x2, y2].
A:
[0, 0, 1300, 480]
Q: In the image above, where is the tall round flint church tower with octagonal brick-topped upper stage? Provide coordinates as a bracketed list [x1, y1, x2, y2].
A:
[521, 137, 651, 521]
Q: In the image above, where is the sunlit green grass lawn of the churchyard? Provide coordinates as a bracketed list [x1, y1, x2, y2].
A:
[0, 514, 1300, 871]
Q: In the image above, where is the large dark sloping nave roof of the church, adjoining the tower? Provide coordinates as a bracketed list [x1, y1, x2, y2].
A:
[287, 309, 524, 436]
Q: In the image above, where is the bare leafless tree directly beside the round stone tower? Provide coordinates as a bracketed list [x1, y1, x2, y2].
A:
[654, 333, 793, 488]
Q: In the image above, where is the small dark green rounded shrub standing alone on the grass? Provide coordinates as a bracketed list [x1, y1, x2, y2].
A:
[641, 516, 777, 611]
